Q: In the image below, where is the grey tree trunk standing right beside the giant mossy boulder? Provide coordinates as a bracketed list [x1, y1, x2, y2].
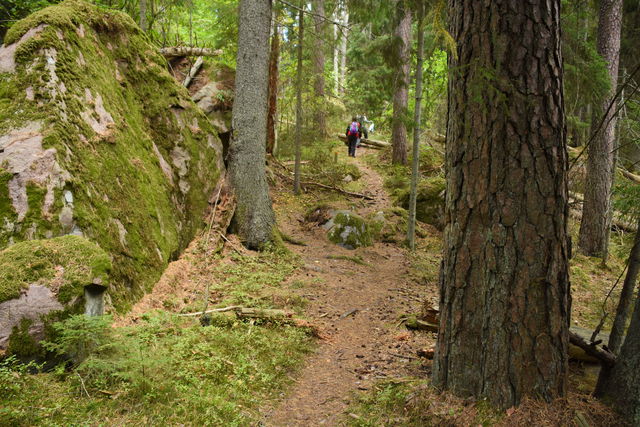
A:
[229, 0, 275, 248]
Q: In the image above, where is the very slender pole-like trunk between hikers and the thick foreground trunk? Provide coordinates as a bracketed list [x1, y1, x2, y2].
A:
[407, 2, 425, 250]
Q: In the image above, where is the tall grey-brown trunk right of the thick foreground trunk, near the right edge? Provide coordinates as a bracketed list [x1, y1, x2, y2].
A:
[578, 0, 622, 257]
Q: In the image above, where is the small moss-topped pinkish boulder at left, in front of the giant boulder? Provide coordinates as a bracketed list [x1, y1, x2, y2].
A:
[0, 236, 112, 356]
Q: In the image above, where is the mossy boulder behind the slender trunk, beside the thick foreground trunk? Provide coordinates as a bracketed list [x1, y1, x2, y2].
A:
[397, 176, 447, 230]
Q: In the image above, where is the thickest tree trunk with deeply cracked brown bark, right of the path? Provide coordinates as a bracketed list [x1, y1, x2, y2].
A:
[433, 0, 570, 408]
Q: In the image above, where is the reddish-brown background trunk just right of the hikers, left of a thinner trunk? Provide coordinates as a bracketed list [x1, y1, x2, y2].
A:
[391, 0, 411, 165]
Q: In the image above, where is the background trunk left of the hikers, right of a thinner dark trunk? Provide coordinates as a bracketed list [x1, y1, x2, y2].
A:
[313, 0, 328, 137]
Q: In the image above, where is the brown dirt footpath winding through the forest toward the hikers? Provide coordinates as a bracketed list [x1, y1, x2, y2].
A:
[263, 150, 434, 427]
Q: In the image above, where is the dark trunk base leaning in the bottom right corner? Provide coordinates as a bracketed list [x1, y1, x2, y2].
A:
[598, 288, 640, 426]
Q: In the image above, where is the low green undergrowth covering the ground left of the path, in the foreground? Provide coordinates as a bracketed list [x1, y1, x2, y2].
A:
[0, 312, 310, 425]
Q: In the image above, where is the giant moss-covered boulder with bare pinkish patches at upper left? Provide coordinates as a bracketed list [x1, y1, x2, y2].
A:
[0, 0, 224, 310]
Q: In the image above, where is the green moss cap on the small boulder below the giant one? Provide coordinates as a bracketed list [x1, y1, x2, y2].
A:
[0, 236, 111, 303]
